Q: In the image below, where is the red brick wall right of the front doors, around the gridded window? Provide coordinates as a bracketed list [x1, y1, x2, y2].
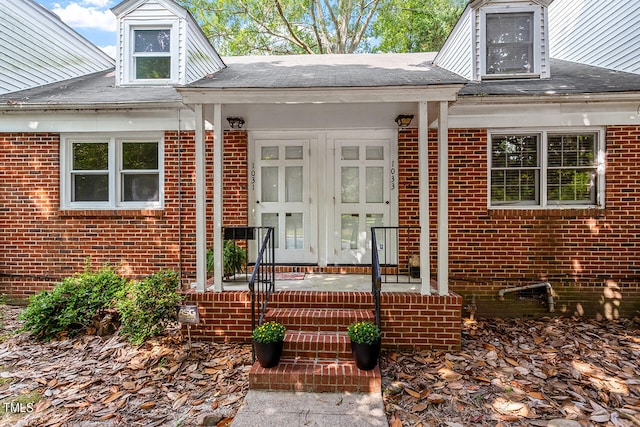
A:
[398, 126, 640, 318]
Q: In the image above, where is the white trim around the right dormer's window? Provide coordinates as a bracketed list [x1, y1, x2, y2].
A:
[478, 6, 542, 80]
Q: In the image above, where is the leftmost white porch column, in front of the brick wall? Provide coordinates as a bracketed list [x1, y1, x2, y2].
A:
[195, 104, 207, 292]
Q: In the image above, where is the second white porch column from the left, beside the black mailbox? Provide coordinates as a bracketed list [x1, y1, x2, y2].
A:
[213, 104, 224, 291]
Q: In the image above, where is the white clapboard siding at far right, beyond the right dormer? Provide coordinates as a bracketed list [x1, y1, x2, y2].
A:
[549, 0, 640, 73]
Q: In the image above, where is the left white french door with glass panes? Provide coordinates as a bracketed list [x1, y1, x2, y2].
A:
[249, 140, 318, 263]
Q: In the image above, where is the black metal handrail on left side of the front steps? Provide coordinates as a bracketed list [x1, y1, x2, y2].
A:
[249, 227, 276, 331]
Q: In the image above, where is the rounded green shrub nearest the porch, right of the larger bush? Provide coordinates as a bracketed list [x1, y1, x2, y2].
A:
[117, 270, 181, 344]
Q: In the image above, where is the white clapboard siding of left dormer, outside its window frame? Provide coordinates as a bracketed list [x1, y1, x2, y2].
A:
[112, 0, 224, 85]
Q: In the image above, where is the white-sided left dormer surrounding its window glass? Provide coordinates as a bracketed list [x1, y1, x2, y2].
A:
[111, 0, 225, 85]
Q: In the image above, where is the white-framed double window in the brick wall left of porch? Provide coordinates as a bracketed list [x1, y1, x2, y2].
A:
[61, 136, 162, 209]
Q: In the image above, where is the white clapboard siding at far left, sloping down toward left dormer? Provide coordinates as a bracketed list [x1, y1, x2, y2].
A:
[0, 0, 114, 94]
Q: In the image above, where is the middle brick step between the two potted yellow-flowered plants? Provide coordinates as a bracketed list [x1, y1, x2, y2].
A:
[282, 331, 353, 360]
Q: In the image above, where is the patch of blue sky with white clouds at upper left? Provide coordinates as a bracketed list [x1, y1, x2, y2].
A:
[38, 0, 121, 57]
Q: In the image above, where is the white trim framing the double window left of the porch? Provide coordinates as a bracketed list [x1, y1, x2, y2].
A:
[60, 133, 164, 210]
